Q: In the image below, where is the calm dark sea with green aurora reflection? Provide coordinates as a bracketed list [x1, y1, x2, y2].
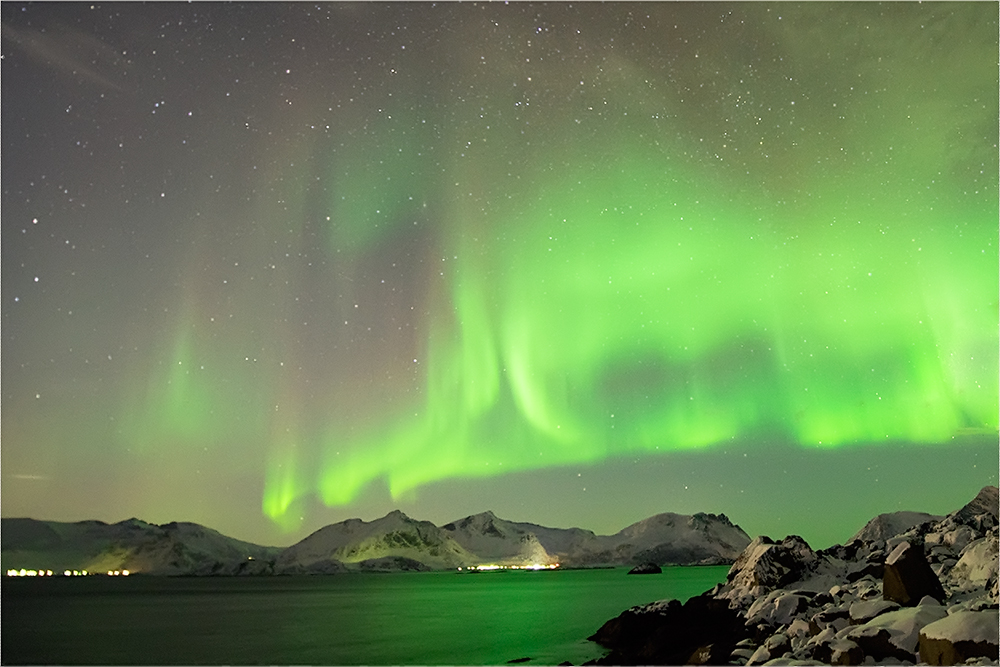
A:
[0, 566, 728, 665]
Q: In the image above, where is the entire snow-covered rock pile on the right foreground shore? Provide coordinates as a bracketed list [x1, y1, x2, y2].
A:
[591, 487, 1000, 665]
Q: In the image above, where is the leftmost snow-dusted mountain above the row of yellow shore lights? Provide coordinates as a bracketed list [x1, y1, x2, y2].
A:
[0, 518, 281, 575]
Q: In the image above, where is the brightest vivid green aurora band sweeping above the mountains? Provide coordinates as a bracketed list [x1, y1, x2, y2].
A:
[284, 144, 998, 519]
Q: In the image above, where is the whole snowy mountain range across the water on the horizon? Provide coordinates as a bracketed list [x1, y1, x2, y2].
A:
[0, 510, 750, 575]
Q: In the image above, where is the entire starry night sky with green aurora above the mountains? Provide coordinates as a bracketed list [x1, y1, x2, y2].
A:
[0, 2, 1000, 547]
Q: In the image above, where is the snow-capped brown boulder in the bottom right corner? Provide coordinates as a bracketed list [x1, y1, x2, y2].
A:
[919, 609, 1000, 665]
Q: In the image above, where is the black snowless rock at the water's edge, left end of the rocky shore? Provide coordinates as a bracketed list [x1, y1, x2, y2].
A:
[590, 596, 748, 665]
